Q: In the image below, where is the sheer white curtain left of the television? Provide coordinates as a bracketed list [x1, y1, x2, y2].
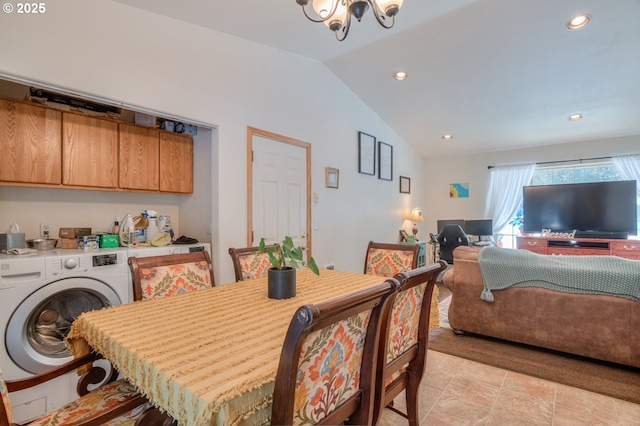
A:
[484, 164, 536, 233]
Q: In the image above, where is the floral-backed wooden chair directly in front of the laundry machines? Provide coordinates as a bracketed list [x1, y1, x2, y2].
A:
[129, 250, 215, 300]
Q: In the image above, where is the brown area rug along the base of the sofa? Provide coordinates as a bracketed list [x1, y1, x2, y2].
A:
[428, 311, 640, 404]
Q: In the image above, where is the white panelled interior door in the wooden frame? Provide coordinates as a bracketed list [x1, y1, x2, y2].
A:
[250, 129, 310, 250]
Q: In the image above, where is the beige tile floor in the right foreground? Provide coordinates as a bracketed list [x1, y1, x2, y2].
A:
[379, 351, 640, 426]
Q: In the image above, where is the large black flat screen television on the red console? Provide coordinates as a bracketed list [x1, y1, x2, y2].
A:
[523, 180, 638, 238]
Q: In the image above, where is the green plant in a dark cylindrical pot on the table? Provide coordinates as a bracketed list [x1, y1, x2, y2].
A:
[258, 236, 320, 299]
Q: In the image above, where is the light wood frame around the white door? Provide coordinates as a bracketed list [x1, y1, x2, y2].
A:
[247, 126, 313, 260]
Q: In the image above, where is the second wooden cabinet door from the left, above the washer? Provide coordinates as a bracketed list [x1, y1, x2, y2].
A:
[62, 113, 118, 188]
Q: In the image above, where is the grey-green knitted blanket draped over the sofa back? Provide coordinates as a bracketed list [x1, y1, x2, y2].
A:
[478, 247, 640, 302]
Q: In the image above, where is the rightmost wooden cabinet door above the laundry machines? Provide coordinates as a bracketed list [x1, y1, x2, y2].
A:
[160, 132, 193, 194]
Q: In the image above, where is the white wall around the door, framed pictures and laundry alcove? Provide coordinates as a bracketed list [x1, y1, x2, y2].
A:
[0, 0, 428, 283]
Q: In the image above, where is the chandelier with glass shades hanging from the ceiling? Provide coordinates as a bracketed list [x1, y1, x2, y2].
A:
[296, 0, 403, 41]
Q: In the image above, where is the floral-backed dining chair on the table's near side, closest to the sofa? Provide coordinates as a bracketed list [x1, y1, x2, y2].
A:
[373, 260, 447, 426]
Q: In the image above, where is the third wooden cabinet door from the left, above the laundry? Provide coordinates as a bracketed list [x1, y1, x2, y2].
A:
[118, 124, 160, 191]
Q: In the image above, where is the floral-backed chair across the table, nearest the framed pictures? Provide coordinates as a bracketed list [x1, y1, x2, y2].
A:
[364, 241, 420, 277]
